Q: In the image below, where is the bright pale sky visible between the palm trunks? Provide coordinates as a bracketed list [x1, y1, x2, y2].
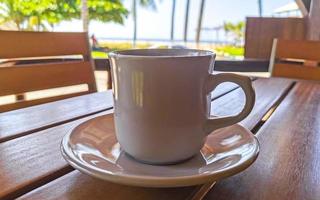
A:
[55, 0, 294, 40]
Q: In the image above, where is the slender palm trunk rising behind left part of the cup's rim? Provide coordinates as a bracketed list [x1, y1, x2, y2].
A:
[132, 0, 157, 48]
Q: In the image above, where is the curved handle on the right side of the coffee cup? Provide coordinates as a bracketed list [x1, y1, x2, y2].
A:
[205, 73, 255, 134]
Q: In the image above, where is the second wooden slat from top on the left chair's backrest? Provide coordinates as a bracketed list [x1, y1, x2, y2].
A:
[0, 62, 94, 96]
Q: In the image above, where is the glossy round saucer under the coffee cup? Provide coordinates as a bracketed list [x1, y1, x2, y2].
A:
[61, 115, 259, 187]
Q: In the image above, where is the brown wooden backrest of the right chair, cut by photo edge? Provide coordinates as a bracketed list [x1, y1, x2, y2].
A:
[269, 39, 320, 80]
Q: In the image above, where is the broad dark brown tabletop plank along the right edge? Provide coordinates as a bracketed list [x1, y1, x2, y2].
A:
[205, 82, 320, 200]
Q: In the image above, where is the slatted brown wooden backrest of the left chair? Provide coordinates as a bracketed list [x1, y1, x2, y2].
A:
[0, 31, 97, 112]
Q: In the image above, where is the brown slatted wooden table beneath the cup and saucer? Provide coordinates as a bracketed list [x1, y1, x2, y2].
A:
[0, 78, 320, 200]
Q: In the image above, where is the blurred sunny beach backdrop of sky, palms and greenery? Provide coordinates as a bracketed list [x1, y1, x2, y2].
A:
[0, 0, 303, 60]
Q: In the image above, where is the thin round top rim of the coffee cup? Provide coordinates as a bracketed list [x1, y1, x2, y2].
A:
[109, 48, 216, 58]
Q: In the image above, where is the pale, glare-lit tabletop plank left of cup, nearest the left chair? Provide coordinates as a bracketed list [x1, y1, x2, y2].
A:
[0, 91, 113, 143]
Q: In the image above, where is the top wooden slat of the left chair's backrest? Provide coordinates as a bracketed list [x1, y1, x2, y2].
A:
[0, 31, 90, 59]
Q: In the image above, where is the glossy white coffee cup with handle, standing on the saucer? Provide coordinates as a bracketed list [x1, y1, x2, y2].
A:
[109, 49, 255, 164]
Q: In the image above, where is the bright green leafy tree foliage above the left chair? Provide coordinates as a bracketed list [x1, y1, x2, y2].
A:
[0, 0, 128, 30]
